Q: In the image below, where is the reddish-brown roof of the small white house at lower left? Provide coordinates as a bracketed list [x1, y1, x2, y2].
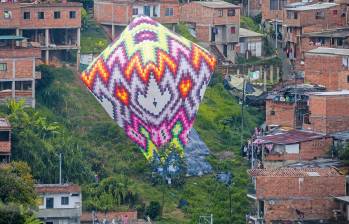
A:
[35, 184, 81, 194]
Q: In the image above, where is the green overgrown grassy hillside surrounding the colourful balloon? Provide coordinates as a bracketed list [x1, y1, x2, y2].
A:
[6, 17, 262, 223]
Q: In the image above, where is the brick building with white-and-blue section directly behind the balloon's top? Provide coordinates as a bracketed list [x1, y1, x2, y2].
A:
[94, 0, 180, 38]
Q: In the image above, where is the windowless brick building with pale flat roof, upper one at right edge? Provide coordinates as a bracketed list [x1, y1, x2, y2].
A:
[304, 47, 349, 90]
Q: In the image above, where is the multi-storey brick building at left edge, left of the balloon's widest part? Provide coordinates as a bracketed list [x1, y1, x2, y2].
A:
[0, 35, 41, 107]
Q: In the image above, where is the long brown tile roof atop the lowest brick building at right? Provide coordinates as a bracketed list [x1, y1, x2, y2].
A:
[248, 168, 341, 177]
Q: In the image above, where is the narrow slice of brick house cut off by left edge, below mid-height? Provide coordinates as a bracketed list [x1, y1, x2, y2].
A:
[0, 118, 12, 163]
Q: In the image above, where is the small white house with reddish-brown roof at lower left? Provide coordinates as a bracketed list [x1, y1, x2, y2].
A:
[35, 184, 82, 224]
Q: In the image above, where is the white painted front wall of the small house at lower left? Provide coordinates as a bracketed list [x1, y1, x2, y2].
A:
[39, 193, 81, 209]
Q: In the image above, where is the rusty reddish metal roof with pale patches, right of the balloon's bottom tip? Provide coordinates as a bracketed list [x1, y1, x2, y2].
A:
[251, 130, 325, 145]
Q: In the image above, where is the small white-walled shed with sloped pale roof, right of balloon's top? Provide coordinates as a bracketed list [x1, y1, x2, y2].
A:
[239, 28, 263, 57]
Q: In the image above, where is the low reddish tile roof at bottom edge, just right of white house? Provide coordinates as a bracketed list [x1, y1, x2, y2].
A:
[80, 211, 137, 222]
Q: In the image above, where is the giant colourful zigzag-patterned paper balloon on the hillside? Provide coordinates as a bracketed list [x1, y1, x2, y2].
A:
[81, 17, 216, 159]
